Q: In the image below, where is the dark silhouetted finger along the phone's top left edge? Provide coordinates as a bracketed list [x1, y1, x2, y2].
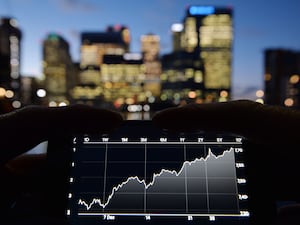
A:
[0, 105, 123, 163]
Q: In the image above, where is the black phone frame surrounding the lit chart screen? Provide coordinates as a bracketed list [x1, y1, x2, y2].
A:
[47, 120, 274, 224]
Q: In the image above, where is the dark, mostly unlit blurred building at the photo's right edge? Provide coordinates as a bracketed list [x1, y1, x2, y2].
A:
[264, 49, 300, 108]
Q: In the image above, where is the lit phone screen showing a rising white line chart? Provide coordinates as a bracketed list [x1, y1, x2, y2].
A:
[65, 121, 250, 225]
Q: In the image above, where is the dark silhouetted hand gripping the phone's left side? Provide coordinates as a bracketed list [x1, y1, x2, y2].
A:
[0, 105, 123, 224]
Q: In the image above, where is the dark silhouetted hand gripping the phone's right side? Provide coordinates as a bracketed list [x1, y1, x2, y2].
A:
[153, 100, 300, 225]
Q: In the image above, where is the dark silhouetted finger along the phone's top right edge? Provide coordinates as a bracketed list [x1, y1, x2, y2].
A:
[153, 100, 300, 142]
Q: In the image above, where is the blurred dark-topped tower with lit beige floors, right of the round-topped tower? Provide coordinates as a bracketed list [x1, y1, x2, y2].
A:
[72, 25, 130, 107]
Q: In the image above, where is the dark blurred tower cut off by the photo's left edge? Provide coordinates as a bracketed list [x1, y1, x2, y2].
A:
[0, 17, 22, 108]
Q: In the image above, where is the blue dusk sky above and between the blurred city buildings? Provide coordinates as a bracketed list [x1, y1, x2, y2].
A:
[0, 0, 300, 98]
